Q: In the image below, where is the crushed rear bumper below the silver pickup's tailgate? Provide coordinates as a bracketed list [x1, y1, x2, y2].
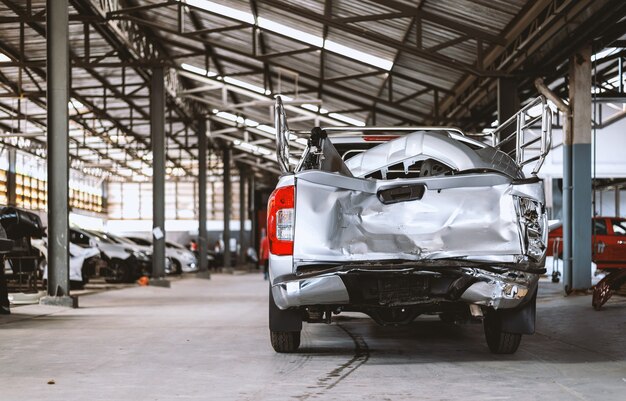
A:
[272, 267, 539, 309]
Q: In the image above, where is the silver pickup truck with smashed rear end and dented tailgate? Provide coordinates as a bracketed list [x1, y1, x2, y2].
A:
[268, 98, 551, 353]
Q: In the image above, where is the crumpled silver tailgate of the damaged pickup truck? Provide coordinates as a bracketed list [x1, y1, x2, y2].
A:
[294, 172, 522, 266]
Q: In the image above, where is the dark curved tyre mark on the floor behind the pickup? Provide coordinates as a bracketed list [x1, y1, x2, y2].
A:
[292, 323, 370, 400]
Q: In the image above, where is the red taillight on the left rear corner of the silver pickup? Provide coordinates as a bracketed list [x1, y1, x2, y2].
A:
[267, 185, 295, 255]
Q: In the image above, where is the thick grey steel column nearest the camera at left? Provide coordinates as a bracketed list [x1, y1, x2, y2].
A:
[40, 0, 78, 307]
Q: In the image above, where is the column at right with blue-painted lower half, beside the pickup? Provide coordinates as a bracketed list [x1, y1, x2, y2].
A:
[563, 45, 592, 292]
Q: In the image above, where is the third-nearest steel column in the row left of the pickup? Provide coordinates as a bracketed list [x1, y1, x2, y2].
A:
[198, 118, 210, 277]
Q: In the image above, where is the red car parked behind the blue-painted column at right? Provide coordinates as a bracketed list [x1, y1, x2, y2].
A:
[547, 217, 626, 269]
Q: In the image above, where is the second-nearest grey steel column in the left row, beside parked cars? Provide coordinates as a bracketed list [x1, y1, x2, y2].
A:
[150, 67, 169, 287]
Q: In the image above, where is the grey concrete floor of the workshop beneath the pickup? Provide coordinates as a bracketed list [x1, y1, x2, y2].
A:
[0, 274, 626, 401]
